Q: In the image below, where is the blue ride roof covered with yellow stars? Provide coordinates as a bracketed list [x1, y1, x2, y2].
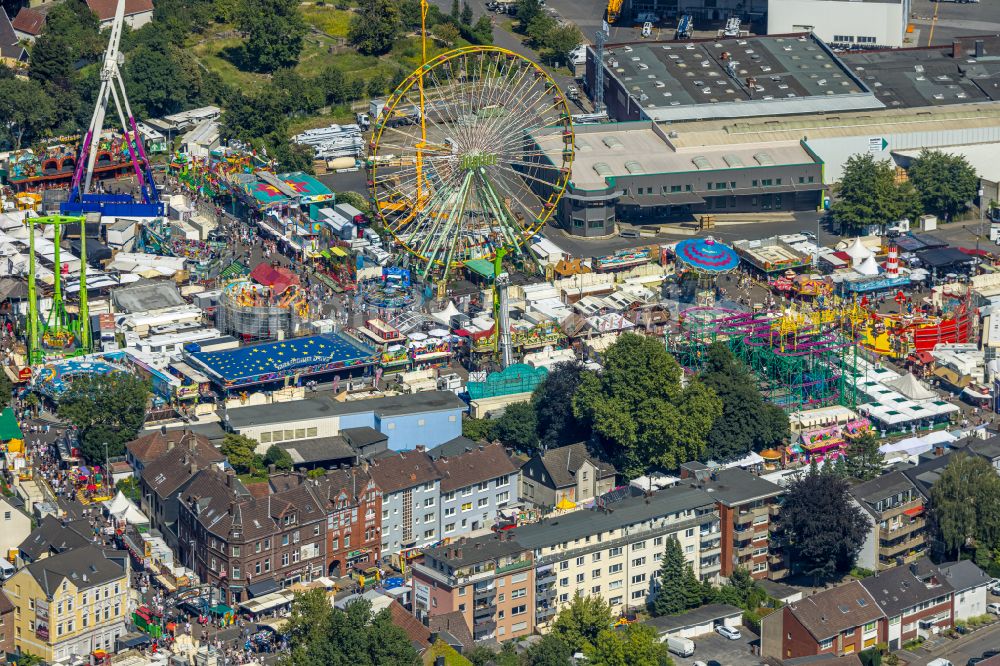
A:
[191, 333, 375, 382]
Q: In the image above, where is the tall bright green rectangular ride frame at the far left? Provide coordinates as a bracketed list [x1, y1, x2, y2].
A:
[25, 215, 91, 365]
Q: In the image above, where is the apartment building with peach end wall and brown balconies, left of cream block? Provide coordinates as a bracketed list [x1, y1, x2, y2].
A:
[412, 532, 535, 641]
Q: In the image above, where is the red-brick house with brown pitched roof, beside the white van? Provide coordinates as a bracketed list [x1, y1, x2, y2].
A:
[760, 581, 886, 660]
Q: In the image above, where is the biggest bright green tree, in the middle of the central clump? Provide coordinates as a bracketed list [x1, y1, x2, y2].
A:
[573, 333, 722, 477]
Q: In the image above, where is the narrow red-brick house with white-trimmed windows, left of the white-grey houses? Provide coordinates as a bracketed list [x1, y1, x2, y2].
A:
[315, 465, 382, 576]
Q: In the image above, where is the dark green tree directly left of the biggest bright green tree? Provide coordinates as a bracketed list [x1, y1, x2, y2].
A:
[531, 361, 593, 448]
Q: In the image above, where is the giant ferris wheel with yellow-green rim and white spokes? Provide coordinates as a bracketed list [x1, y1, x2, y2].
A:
[368, 46, 573, 279]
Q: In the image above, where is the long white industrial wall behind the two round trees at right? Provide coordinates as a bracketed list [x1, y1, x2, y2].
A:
[804, 124, 1000, 185]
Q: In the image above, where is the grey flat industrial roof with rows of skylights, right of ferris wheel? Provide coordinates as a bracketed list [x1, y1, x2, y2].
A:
[604, 34, 881, 120]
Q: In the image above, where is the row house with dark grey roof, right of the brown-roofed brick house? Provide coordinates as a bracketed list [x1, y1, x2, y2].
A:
[861, 559, 955, 650]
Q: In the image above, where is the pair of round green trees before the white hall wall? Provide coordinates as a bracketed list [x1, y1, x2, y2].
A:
[831, 150, 979, 232]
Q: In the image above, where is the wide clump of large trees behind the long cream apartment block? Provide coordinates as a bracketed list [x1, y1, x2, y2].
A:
[465, 334, 789, 475]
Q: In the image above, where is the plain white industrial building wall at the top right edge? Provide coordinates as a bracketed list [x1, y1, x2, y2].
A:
[767, 0, 908, 47]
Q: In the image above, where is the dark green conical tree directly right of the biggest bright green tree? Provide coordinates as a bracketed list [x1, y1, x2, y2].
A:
[701, 343, 790, 460]
